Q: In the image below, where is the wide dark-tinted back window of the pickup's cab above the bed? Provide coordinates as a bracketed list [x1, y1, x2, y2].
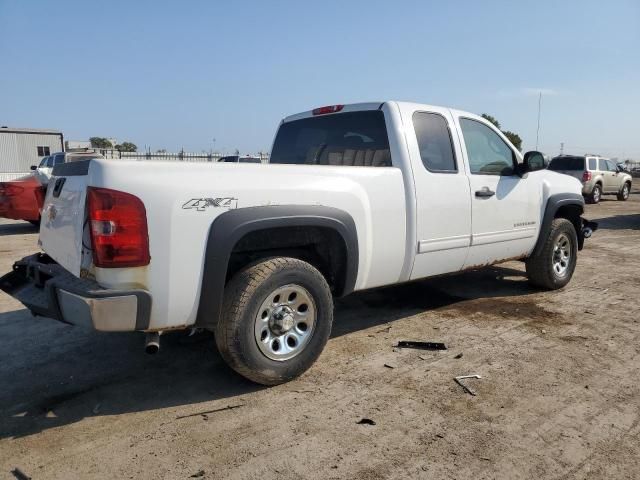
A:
[269, 110, 392, 167]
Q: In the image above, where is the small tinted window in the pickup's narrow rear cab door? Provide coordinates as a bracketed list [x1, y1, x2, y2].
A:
[413, 112, 458, 173]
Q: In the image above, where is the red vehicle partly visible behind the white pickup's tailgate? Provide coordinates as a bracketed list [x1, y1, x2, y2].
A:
[0, 175, 46, 223]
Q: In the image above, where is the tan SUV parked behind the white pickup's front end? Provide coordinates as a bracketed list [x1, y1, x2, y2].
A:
[549, 155, 632, 203]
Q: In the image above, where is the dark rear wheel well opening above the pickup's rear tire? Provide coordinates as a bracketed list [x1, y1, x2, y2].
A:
[226, 226, 347, 295]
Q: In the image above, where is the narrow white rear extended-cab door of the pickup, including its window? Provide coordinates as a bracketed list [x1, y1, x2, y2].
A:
[401, 106, 471, 279]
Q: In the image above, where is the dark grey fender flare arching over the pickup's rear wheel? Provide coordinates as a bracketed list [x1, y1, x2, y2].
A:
[195, 205, 359, 328]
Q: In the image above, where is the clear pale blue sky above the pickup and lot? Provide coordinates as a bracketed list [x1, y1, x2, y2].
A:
[0, 0, 640, 160]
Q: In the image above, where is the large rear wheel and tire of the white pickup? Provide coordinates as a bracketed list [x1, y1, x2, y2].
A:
[215, 257, 333, 385]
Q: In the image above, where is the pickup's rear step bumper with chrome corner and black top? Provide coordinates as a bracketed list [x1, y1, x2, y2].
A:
[0, 253, 151, 332]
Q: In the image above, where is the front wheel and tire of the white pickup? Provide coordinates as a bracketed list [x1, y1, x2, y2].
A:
[526, 218, 578, 290]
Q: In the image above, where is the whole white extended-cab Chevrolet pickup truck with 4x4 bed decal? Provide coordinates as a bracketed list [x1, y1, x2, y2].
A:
[0, 101, 595, 385]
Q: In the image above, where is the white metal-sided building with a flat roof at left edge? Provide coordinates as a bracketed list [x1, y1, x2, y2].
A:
[0, 127, 64, 181]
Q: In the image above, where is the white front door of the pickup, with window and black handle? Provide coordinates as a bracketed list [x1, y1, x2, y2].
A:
[457, 117, 542, 268]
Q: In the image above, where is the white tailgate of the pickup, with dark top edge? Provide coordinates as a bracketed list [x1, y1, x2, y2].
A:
[40, 160, 91, 277]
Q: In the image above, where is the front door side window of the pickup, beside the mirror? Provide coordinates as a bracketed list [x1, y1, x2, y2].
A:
[460, 118, 515, 175]
